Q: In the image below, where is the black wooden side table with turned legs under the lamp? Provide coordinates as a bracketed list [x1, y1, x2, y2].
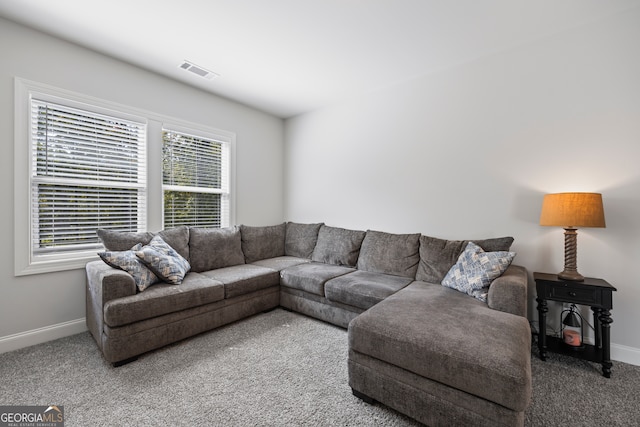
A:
[533, 273, 616, 378]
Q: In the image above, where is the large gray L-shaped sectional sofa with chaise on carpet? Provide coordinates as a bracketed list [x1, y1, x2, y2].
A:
[86, 222, 531, 425]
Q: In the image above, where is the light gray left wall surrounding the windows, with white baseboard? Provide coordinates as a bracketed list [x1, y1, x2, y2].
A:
[0, 18, 284, 351]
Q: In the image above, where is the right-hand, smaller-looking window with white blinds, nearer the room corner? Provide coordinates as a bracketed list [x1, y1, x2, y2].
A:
[162, 128, 229, 228]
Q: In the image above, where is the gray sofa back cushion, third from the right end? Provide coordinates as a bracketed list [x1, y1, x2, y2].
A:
[311, 225, 366, 267]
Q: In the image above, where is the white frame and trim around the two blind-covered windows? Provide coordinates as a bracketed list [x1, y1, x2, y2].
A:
[14, 77, 236, 276]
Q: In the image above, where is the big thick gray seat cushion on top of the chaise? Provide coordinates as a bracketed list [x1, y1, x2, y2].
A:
[349, 282, 531, 411]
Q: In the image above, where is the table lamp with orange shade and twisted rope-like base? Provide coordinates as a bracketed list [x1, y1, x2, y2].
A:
[540, 193, 605, 281]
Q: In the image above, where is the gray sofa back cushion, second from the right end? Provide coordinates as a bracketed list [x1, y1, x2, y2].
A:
[358, 230, 422, 279]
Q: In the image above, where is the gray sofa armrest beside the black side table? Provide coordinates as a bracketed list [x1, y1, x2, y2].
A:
[487, 265, 528, 317]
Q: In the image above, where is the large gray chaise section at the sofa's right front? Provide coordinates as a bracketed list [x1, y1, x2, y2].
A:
[348, 266, 531, 426]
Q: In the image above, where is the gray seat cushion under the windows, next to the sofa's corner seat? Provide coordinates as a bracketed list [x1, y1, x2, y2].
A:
[202, 264, 280, 299]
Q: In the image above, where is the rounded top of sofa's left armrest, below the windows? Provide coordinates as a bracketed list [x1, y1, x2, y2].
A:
[86, 261, 136, 307]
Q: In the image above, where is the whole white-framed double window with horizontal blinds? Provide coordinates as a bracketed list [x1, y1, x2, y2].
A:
[14, 78, 235, 276]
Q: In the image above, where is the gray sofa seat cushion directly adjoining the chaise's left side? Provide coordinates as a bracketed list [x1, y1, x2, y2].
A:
[324, 270, 413, 310]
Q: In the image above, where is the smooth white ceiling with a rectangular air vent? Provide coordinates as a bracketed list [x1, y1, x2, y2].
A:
[0, 0, 640, 118]
